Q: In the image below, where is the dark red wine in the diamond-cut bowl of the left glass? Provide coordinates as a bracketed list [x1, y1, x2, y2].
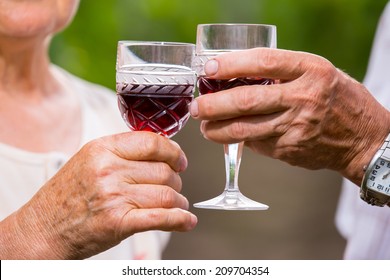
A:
[116, 83, 194, 137]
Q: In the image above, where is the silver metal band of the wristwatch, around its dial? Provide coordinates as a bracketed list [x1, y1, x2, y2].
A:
[360, 133, 390, 207]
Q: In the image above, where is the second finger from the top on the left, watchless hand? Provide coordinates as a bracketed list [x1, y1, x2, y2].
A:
[116, 160, 182, 192]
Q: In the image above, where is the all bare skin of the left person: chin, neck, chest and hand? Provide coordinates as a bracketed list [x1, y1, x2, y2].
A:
[0, 0, 197, 259]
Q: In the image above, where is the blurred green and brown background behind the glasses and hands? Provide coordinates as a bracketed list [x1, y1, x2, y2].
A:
[51, 0, 387, 259]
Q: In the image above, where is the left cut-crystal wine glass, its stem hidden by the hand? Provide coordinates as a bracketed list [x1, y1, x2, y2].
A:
[116, 41, 196, 137]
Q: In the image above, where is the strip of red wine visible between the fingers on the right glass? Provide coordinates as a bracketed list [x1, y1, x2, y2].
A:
[198, 77, 274, 94]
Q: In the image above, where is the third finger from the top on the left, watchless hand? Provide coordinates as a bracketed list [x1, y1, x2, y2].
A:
[120, 184, 189, 210]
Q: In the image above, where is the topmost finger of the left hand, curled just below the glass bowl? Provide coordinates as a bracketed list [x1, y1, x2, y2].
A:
[102, 131, 187, 172]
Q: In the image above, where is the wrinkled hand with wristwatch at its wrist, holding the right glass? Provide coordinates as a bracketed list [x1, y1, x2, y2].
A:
[191, 48, 390, 183]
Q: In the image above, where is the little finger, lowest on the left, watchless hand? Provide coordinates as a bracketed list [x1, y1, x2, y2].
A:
[123, 208, 198, 235]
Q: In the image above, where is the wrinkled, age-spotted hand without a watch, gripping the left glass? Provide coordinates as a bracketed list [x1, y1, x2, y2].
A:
[0, 132, 197, 259]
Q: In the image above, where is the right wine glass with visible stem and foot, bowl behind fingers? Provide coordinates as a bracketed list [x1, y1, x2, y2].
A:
[193, 24, 276, 210]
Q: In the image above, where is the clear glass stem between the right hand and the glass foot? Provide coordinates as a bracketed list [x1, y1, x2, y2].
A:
[223, 142, 244, 192]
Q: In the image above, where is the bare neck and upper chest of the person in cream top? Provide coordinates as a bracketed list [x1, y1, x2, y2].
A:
[0, 36, 82, 154]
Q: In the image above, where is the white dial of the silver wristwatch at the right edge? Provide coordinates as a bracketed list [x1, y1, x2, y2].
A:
[367, 158, 390, 195]
